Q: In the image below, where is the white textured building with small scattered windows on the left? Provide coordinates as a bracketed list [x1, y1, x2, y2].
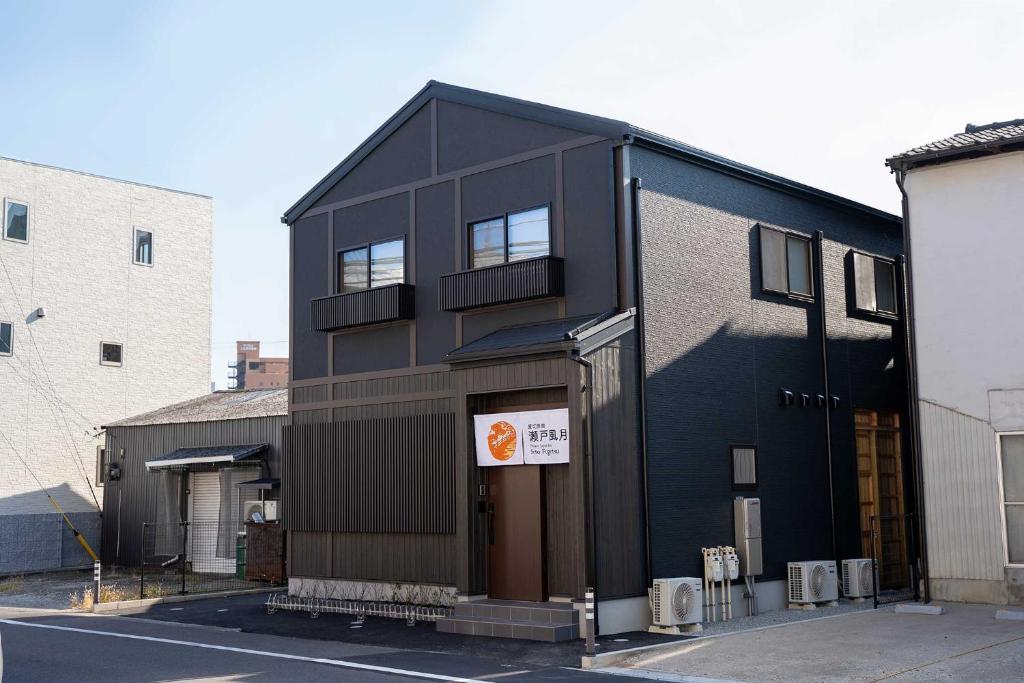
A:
[0, 158, 213, 574]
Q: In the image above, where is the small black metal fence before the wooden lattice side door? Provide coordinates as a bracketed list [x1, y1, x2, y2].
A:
[870, 513, 921, 607]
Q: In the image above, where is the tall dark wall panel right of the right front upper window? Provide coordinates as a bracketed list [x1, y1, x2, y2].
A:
[562, 142, 615, 316]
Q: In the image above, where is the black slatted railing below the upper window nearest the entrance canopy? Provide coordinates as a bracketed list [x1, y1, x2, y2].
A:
[438, 256, 565, 311]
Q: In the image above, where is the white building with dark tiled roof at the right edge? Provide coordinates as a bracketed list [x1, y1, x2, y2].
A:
[887, 120, 1024, 604]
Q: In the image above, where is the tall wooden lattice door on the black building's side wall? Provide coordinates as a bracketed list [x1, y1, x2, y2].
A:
[854, 410, 909, 589]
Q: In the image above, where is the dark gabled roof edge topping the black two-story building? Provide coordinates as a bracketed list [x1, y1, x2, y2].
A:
[281, 81, 900, 224]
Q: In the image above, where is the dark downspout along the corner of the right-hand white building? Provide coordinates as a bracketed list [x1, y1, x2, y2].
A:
[893, 168, 932, 602]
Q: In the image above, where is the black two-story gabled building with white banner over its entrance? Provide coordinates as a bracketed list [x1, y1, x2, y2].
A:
[282, 82, 914, 635]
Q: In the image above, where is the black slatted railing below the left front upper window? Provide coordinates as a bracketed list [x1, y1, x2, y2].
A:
[309, 285, 416, 332]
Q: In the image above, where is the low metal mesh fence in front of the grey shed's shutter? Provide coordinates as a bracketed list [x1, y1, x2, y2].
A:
[138, 521, 287, 598]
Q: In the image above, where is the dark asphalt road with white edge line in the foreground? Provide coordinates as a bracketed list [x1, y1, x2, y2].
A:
[0, 608, 635, 683]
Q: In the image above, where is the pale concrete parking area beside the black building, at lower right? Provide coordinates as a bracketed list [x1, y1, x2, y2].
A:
[609, 604, 1024, 683]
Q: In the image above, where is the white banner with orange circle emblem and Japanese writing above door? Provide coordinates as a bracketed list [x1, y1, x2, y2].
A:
[473, 408, 569, 467]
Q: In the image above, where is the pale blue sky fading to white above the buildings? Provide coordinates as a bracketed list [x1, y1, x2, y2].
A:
[0, 0, 1024, 388]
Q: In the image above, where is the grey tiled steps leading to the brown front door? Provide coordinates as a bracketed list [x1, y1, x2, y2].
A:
[437, 600, 580, 643]
